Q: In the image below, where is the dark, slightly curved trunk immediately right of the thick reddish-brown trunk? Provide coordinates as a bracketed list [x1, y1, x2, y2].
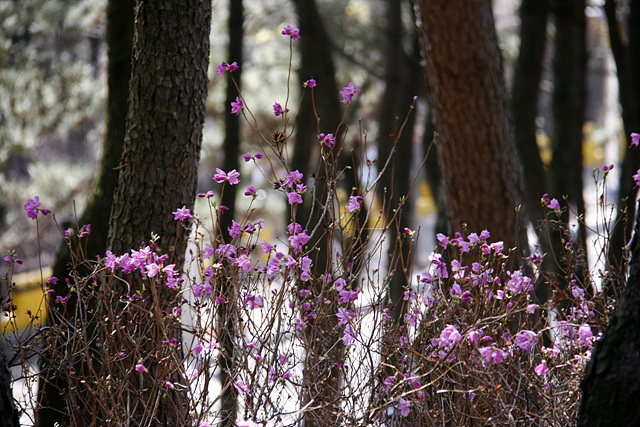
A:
[511, 0, 549, 226]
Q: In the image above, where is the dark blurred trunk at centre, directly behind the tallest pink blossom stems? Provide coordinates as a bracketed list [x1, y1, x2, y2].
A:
[291, 0, 344, 427]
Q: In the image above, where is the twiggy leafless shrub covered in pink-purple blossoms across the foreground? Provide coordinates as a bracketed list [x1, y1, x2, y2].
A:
[3, 26, 637, 426]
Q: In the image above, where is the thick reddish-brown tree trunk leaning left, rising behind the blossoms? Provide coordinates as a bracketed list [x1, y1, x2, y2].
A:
[416, 0, 527, 251]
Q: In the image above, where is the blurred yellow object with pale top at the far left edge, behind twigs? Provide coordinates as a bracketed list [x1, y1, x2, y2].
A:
[0, 267, 52, 334]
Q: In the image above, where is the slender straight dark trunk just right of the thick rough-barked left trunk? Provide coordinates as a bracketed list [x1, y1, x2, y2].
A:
[218, 0, 244, 426]
